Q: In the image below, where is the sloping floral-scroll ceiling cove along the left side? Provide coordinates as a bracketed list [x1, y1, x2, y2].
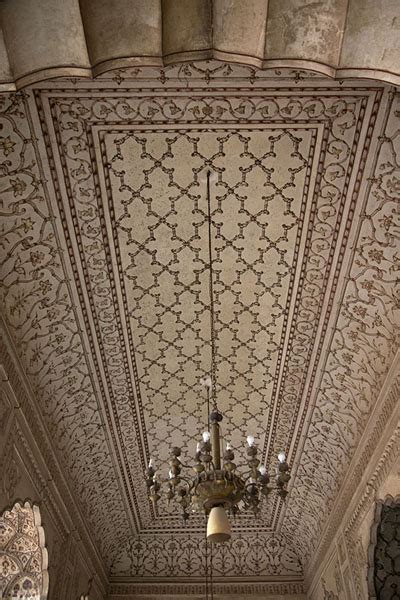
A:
[0, 94, 129, 560]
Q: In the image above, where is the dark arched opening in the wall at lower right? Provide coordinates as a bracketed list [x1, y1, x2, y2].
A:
[368, 496, 400, 600]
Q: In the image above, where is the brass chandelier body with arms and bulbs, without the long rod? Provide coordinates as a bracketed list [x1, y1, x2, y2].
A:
[147, 409, 290, 542]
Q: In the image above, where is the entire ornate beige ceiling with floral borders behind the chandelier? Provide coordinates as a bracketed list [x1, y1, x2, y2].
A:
[0, 63, 399, 585]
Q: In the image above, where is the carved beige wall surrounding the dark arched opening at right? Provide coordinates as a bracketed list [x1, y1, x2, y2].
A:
[307, 354, 400, 600]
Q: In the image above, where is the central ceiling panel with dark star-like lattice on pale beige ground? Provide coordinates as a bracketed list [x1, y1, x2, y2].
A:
[105, 128, 316, 459]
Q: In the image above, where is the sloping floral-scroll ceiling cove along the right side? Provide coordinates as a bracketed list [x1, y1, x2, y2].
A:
[284, 94, 400, 557]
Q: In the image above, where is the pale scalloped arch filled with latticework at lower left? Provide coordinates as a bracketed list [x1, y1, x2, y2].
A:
[0, 501, 49, 600]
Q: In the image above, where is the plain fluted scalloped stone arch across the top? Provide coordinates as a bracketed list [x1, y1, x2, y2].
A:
[0, 0, 400, 90]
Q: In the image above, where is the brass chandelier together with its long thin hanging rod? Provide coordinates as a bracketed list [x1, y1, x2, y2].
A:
[146, 172, 290, 543]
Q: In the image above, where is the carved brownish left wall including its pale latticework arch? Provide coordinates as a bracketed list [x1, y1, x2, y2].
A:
[0, 358, 105, 600]
